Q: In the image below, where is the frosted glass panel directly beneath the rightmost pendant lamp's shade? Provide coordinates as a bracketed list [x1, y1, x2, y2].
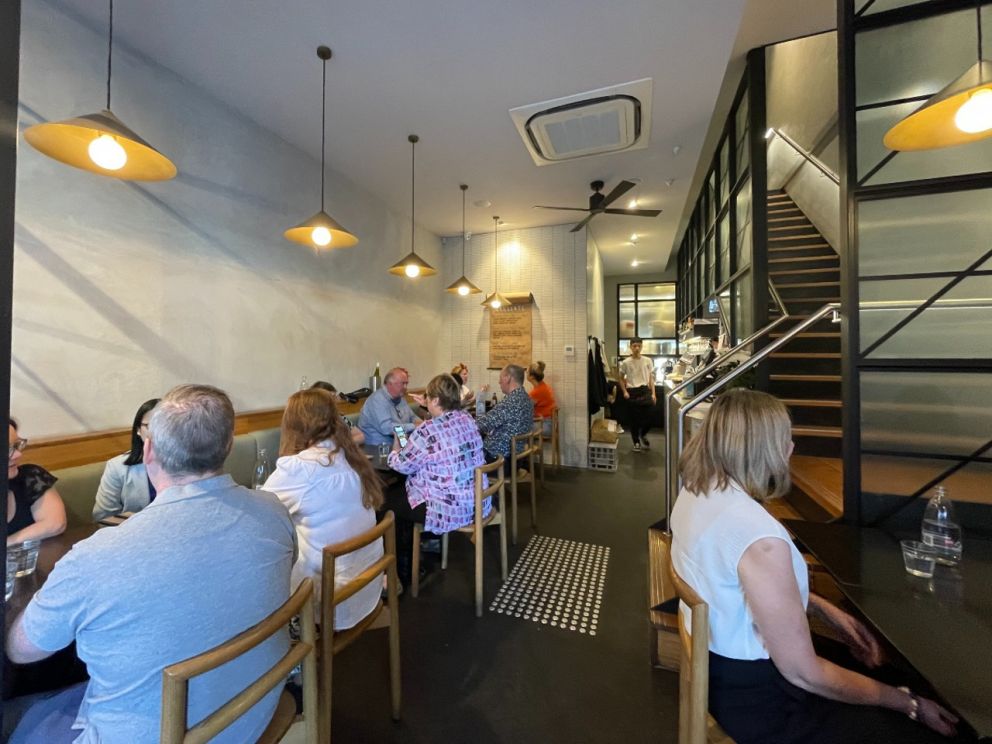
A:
[857, 103, 992, 185]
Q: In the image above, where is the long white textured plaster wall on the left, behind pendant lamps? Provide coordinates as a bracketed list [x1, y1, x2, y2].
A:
[11, 0, 447, 436]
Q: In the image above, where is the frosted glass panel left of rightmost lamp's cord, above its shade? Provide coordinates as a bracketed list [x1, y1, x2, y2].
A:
[855, 10, 978, 108]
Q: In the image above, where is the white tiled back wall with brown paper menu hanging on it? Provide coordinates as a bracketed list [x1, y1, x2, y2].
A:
[442, 225, 589, 467]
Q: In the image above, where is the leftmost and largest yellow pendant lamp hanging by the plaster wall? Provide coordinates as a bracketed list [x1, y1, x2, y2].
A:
[24, 0, 176, 181]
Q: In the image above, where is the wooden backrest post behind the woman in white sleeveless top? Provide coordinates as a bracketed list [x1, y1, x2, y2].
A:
[665, 537, 710, 744]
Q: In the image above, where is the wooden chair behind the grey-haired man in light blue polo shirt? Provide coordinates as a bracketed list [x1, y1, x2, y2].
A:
[160, 579, 322, 744]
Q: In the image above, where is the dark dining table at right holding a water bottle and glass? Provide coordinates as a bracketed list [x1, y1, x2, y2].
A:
[782, 519, 992, 741]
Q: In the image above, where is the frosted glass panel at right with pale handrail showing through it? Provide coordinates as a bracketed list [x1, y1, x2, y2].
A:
[860, 276, 992, 358]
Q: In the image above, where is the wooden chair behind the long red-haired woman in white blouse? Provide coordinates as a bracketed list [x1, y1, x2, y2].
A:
[319, 511, 400, 742]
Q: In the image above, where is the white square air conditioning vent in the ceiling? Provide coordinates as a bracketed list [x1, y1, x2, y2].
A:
[510, 78, 651, 165]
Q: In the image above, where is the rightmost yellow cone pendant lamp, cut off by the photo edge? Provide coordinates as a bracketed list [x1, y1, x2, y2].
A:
[883, 2, 992, 150]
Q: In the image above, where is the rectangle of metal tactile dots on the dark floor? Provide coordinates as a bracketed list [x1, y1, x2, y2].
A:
[489, 535, 610, 636]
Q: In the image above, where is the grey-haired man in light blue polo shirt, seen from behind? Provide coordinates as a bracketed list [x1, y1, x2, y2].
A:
[7, 385, 296, 743]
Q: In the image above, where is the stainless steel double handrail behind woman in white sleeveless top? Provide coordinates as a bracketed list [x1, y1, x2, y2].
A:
[665, 302, 840, 533]
